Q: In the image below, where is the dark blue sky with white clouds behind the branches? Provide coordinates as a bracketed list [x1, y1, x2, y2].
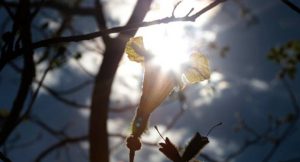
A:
[0, 0, 300, 162]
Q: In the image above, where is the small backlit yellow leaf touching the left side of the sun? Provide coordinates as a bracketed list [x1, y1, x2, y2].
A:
[125, 37, 144, 62]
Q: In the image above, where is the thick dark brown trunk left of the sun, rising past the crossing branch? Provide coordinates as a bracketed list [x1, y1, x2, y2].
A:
[89, 0, 152, 162]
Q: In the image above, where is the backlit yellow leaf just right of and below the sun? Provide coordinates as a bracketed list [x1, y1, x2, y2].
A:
[184, 53, 210, 84]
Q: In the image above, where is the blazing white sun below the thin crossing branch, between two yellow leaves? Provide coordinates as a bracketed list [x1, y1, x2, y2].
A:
[144, 24, 189, 72]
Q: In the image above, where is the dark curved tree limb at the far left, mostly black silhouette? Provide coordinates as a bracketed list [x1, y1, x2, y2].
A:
[0, 0, 35, 145]
